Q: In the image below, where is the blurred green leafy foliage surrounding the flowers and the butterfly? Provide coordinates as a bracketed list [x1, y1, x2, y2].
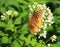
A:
[0, 0, 60, 47]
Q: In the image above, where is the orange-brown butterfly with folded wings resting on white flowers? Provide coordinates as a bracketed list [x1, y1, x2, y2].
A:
[29, 10, 42, 34]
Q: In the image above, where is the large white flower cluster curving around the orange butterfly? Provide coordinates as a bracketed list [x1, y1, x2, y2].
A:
[29, 2, 54, 38]
